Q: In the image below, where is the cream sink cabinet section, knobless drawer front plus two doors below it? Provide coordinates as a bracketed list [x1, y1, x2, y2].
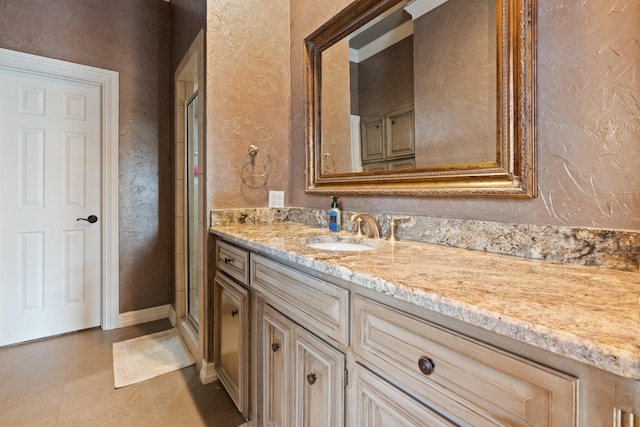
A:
[251, 255, 349, 427]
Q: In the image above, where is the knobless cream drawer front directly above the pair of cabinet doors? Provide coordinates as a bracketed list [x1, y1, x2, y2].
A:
[251, 254, 349, 345]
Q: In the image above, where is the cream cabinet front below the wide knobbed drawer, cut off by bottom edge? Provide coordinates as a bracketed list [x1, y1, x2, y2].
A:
[351, 364, 455, 427]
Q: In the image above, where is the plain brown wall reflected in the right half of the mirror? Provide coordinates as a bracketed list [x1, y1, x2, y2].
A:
[413, 0, 497, 167]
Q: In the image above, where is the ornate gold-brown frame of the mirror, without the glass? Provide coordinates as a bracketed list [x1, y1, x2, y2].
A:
[304, 0, 537, 198]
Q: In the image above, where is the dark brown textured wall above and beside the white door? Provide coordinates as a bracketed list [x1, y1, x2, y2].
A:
[0, 0, 172, 313]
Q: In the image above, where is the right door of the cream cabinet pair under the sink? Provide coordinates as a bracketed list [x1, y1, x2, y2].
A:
[294, 327, 345, 427]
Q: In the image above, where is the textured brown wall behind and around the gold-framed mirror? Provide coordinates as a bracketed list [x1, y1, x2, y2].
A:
[291, 0, 640, 230]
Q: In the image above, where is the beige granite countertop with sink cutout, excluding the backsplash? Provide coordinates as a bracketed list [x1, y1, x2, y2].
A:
[211, 222, 640, 380]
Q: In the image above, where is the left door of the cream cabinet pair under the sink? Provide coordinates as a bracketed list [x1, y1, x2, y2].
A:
[262, 305, 295, 427]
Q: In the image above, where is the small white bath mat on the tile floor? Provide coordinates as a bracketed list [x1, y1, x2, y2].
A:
[113, 328, 195, 388]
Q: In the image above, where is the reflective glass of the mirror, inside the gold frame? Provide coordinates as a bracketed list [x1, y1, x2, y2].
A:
[320, 0, 497, 174]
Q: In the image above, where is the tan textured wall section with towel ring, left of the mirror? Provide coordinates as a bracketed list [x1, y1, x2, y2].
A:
[206, 0, 292, 209]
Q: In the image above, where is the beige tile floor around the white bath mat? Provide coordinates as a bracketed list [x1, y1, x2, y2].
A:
[0, 320, 244, 427]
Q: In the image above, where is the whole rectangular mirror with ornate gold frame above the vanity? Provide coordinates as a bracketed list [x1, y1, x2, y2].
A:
[305, 0, 537, 197]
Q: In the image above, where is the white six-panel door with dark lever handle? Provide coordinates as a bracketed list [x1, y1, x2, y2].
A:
[0, 69, 101, 346]
